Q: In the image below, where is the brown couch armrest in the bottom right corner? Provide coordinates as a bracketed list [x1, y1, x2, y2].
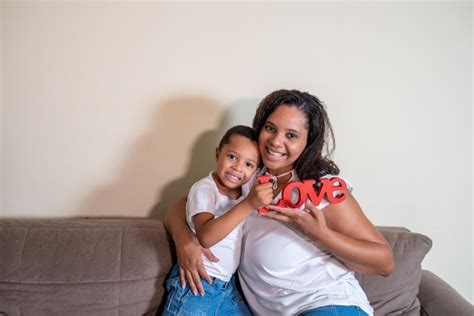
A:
[418, 270, 473, 316]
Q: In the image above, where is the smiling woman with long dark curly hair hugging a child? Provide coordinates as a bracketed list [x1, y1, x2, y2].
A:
[166, 90, 393, 315]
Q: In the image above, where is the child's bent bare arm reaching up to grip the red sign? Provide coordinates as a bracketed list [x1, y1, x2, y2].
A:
[193, 183, 273, 248]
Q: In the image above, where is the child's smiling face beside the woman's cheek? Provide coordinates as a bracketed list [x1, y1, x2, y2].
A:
[216, 134, 260, 194]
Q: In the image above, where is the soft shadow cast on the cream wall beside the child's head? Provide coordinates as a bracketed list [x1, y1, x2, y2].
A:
[76, 96, 258, 218]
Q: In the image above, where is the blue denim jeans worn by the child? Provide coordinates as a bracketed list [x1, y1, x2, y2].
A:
[163, 264, 252, 316]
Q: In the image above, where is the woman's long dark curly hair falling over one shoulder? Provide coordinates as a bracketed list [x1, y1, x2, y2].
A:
[253, 90, 339, 180]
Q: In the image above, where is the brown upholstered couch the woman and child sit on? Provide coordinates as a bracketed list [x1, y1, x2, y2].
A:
[0, 219, 473, 316]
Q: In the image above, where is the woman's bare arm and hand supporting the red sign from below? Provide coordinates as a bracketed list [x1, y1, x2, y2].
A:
[264, 191, 394, 276]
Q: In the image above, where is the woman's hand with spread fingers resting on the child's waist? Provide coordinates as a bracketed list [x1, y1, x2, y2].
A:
[176, 236, 219, 296]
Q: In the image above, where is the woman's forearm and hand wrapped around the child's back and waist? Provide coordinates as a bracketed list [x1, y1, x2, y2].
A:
[164, 198, 219, 295]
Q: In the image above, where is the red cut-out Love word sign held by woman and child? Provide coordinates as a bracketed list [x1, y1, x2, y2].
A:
[257, 176, 347, 213]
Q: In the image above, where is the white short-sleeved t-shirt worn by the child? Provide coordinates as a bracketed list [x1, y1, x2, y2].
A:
[186, 172, 248, 282]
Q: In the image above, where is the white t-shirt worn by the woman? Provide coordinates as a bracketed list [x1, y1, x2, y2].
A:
[239, 176, 373, 315]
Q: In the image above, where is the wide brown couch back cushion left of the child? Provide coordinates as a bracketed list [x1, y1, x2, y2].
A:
[0, 219, 171, 316]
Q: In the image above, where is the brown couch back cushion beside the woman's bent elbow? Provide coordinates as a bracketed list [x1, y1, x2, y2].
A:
[356, 227, 432, 315]
